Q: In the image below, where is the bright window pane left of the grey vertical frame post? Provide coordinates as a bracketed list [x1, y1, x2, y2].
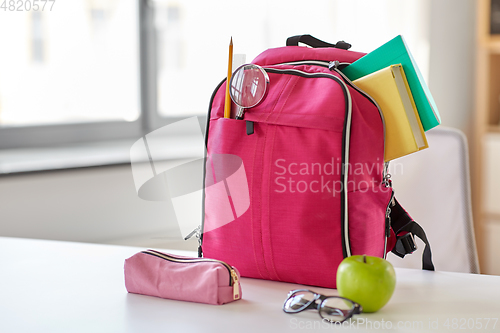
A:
[0, 0, 141, 148]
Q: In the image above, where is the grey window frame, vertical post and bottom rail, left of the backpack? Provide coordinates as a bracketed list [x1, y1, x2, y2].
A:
[0, 0, 204, 149]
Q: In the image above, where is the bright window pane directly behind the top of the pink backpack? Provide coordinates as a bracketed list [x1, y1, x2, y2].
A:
[152, 0, 429, 117]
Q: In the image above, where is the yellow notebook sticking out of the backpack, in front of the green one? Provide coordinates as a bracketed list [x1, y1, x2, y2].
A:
[353, 64, 429, 162]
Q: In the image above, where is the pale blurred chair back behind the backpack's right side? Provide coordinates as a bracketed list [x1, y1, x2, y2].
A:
[387, 126, 479, 273]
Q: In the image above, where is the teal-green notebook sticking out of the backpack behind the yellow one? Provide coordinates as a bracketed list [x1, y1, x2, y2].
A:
[342, 35, 441, 131]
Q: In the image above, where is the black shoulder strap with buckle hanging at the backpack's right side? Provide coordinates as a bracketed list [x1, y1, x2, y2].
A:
[391, 198, 434, 271]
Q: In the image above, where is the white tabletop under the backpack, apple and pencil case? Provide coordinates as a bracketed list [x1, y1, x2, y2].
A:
[0, 237, 500, 333]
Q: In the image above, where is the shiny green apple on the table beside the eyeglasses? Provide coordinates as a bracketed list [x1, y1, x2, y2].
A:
[337, 255, 396, 312]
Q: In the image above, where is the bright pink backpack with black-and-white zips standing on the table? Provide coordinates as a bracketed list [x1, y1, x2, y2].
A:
[200, 35, 433, 288]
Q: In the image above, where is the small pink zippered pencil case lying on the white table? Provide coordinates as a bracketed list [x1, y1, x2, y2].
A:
[125, 250, 241, 305]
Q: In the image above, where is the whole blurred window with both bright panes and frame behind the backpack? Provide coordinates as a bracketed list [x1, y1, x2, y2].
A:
[0, 0, 429, 148]
